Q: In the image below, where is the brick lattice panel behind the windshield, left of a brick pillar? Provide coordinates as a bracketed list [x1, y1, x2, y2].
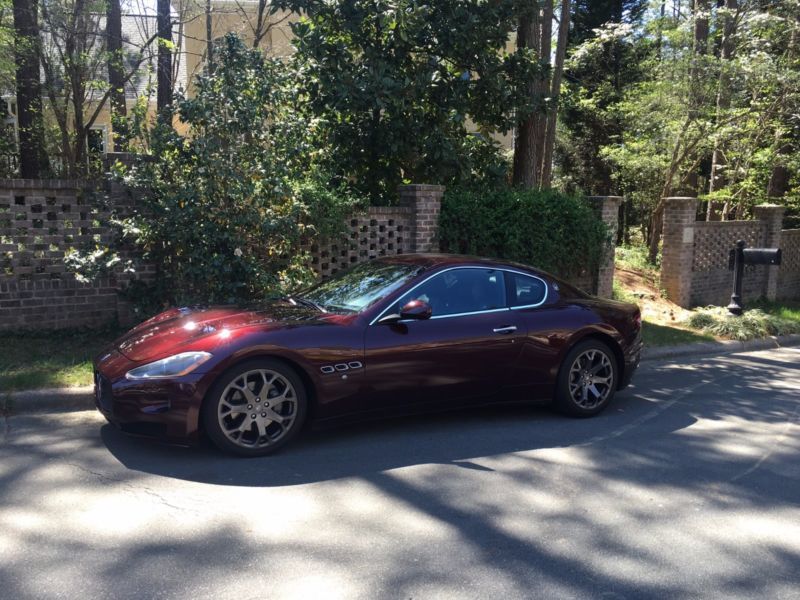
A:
[309, 206, 414, 277]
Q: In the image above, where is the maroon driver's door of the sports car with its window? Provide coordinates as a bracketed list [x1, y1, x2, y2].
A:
[364, 267, 526, 409]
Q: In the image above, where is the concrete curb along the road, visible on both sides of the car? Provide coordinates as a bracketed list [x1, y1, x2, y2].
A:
[9, 334, 800, 415]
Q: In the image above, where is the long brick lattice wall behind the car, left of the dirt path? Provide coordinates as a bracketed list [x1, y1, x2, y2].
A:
[0, 178, 621, 331]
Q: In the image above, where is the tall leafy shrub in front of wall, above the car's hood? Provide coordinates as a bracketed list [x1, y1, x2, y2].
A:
[70, 34, 358, 308]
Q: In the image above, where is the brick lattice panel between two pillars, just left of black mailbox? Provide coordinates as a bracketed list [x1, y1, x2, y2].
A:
[692, 221, 766, 272]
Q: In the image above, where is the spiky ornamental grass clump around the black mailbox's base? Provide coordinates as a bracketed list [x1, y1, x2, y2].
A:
[686, 302, 800, 341]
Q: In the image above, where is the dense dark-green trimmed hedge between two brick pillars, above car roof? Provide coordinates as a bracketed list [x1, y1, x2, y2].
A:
[439, 187, 610, 277]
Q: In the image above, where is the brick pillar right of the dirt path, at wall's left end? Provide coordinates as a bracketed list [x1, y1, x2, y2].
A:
[661, 198, 697, 308]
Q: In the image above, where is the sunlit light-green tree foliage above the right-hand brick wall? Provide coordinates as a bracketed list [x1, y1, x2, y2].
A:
[557, 0, 800, 246]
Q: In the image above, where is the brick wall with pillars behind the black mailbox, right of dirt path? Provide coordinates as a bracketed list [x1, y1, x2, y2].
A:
[661, 198, 800, 307]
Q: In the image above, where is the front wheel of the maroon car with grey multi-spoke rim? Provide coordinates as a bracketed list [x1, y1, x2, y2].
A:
[201, 358, 308, 457]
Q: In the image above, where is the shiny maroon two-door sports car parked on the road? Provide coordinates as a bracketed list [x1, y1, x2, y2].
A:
[95, 254, 642, 456]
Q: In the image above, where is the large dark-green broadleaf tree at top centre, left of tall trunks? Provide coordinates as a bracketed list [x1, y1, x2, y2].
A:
[273, 0, 536, 203]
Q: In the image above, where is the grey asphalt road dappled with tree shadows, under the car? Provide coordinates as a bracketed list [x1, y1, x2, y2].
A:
[0, 349, 800, 600]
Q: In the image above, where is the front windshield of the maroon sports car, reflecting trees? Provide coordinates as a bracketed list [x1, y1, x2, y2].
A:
[296, 261, 420, 312]
